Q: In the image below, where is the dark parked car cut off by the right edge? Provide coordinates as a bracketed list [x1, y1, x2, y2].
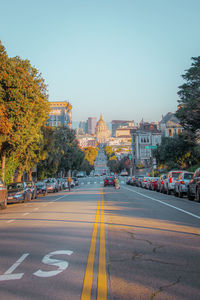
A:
[187, 168, 200, 202]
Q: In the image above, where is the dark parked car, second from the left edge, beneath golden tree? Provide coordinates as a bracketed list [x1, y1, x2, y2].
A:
[7, 182, 31, 203]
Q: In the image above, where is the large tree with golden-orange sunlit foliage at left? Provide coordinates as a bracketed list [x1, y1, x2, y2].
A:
[0, 43, 49, 180]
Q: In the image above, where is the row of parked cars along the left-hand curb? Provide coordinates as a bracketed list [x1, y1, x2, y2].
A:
[0, 178, 79, 209]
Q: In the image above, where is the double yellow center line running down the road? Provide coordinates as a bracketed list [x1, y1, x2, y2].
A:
[81, 189, 107, 300]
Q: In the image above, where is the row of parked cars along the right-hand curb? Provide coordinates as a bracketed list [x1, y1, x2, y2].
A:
[126, 168, 200, 202]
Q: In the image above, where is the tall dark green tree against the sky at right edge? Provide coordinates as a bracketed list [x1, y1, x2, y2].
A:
[176, 56, 200, 140]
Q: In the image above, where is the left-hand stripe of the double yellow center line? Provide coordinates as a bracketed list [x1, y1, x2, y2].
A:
[81, 197, 100, 300]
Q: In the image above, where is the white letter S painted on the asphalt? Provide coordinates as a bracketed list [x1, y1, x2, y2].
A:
[33, 250, 73, 277]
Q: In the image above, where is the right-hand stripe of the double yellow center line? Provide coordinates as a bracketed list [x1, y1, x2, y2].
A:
[97, 190, 107, 300]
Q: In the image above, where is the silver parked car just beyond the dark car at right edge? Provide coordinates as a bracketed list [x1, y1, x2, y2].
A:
[174, 172, 194, 198]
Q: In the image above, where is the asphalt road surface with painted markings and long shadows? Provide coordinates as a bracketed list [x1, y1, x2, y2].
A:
[0, 177, 200, 300]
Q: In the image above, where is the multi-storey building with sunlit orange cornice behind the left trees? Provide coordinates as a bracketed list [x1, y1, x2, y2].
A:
[48, 101, 72, 128]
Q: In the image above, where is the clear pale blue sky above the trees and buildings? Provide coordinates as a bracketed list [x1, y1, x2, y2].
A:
[0, 0, 200, 121]
